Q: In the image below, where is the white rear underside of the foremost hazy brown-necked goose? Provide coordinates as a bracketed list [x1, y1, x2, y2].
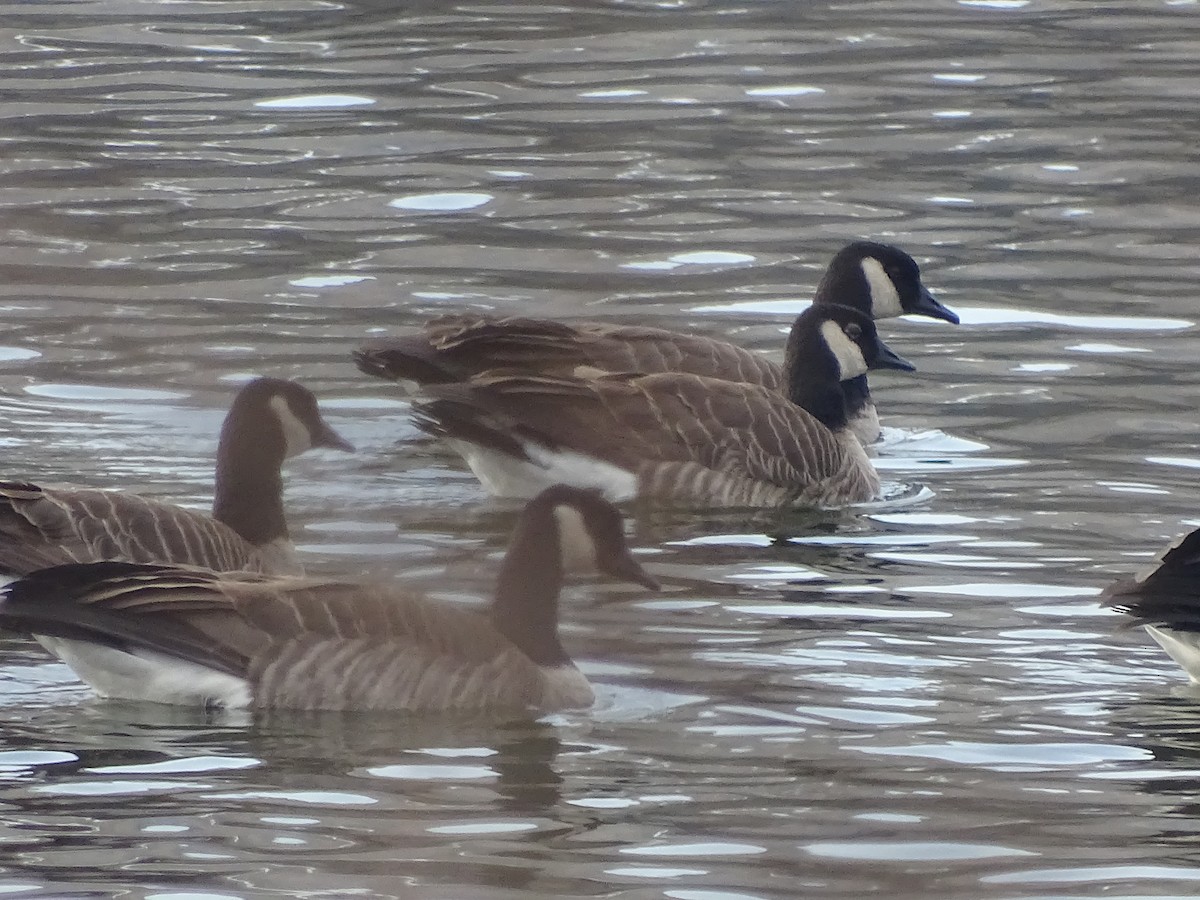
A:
[37, 636, 252, 709]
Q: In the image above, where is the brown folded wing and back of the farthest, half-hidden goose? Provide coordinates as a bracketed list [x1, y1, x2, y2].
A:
[355, 314, 784, 389]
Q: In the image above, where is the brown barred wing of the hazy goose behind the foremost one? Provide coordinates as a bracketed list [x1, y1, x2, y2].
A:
[0, 481, 270, 575]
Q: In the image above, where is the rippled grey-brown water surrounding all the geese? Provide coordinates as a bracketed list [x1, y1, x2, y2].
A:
[0, 0, 1200, 900]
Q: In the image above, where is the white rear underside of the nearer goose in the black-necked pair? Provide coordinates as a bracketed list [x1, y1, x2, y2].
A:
[446, 440, 637, 503]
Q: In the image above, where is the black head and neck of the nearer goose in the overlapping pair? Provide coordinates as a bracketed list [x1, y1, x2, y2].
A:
[784, 304, 916, 430]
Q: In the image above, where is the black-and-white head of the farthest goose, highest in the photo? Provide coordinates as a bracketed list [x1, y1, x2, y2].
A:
[814, 241, 959, 325]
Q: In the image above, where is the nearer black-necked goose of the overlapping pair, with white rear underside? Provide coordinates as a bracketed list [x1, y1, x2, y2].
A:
[413, 304, 912, 506]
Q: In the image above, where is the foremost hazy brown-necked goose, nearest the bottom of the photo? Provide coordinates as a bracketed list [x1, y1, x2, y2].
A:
[0, 485, 658, 712]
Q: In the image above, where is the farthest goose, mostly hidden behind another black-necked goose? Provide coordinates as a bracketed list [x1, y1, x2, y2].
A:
[354, 241, 959, 444]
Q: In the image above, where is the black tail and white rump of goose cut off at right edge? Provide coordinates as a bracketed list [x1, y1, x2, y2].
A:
[1102, 529, 1200, 684]
